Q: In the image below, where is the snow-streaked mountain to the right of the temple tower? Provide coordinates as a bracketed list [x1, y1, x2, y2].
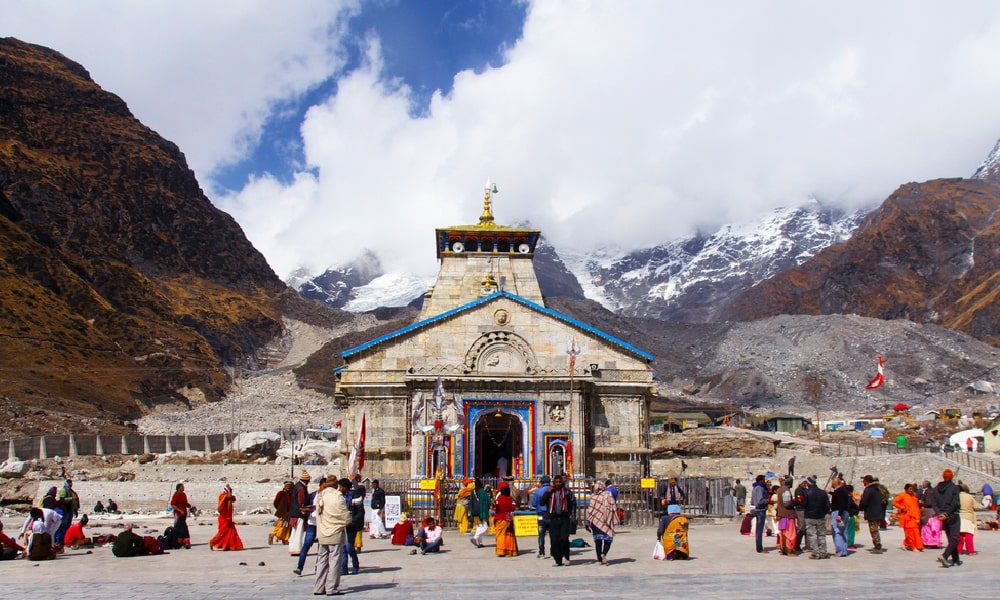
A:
[560, 201, 866, 322]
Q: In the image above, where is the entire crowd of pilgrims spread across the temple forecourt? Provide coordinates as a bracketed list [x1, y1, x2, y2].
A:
[0, 463, 994, 595]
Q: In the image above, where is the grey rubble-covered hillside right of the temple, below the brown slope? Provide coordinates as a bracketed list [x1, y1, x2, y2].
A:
[549, 299, 1000, 414]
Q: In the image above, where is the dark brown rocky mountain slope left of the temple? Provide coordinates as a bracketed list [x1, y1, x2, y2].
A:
[0, 38, 330, 435]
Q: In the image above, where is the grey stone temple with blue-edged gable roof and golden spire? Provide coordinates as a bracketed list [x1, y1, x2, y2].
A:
[334, 184, 655, 478]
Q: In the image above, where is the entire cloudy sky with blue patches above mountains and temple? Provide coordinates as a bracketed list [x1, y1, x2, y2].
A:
[0, 0, 1000, 277]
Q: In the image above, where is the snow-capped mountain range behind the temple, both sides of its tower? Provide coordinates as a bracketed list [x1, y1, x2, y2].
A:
[288, 201, 864, 322]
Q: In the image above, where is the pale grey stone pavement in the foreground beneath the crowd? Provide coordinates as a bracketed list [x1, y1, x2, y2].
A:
[0, 517, 1000, 600]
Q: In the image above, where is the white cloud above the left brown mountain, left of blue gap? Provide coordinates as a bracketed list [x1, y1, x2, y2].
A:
[0, 0, 357, 178]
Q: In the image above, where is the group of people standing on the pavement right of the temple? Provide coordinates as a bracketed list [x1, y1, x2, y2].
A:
[732, 469, 993, 568]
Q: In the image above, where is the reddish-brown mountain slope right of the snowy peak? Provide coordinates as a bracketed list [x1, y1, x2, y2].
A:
[725, 179, 1000, 345]
